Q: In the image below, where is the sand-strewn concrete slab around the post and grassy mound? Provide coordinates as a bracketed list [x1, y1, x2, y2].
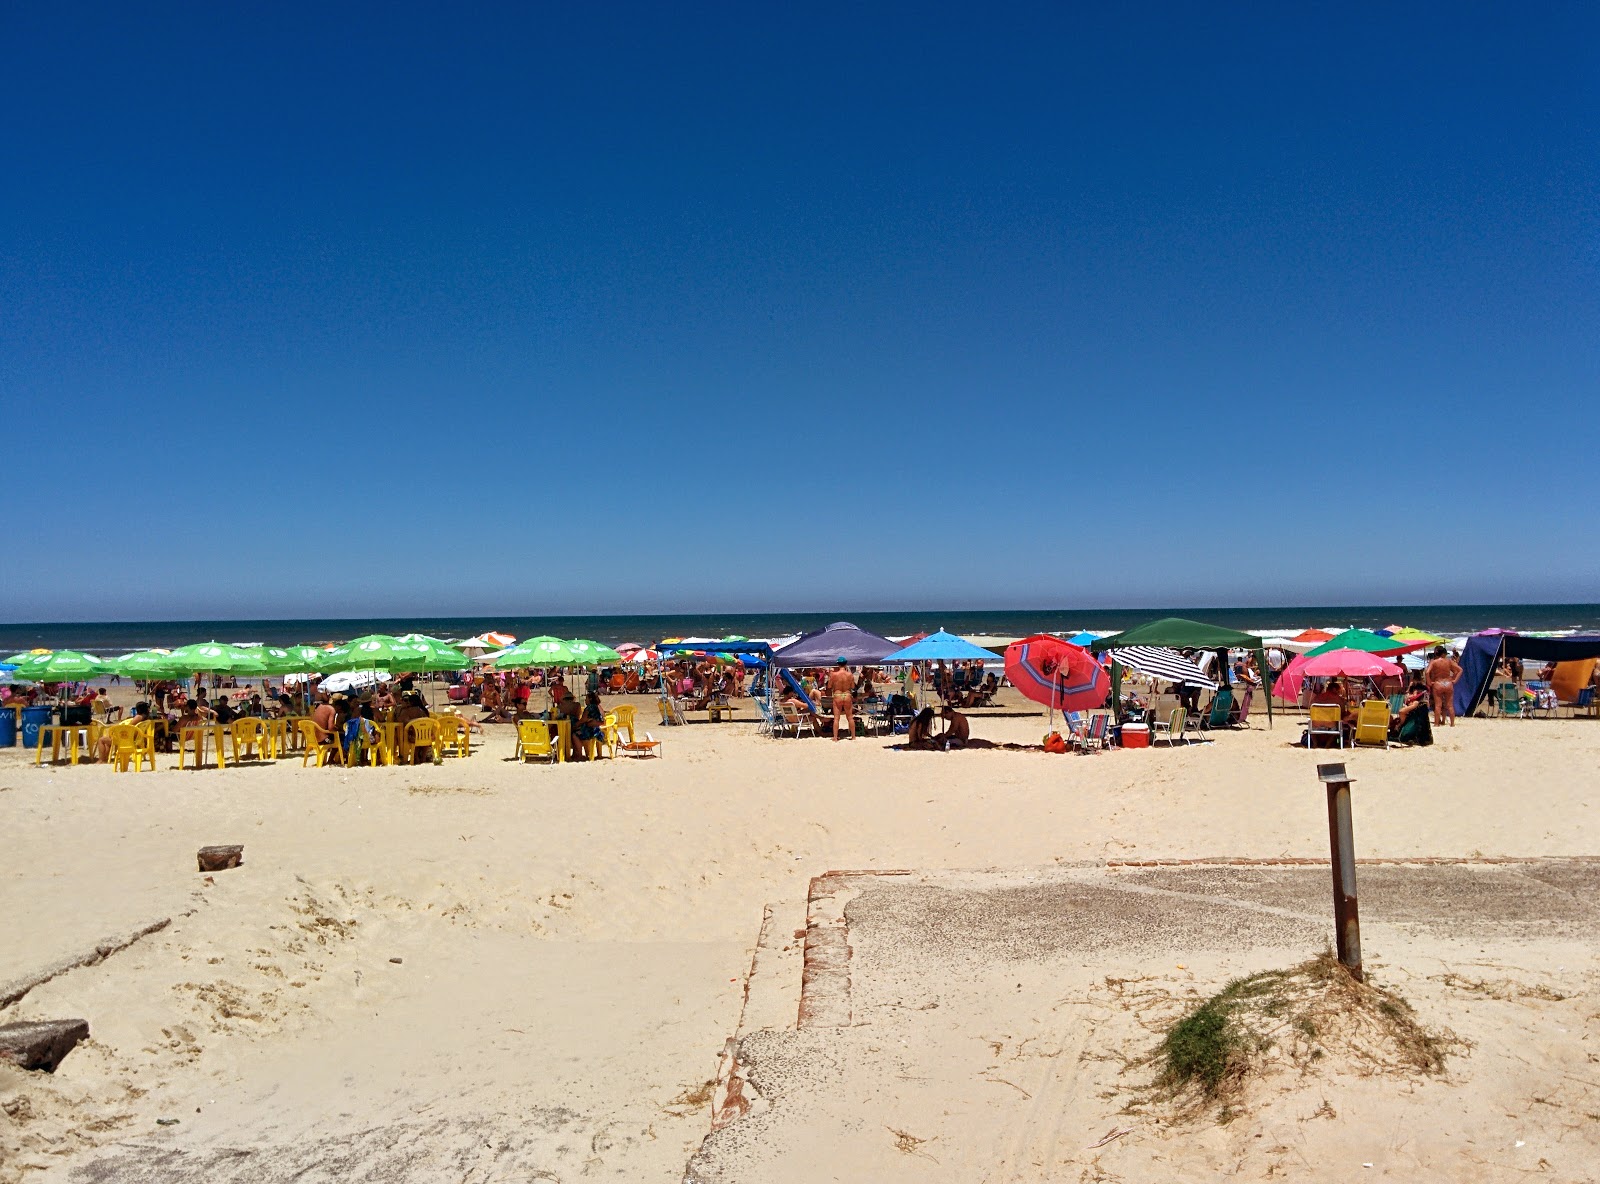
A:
[685, 861, 1600, 1184]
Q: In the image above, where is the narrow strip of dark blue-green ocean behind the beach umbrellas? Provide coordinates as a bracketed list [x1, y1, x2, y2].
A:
[0, 605, 1600, 658]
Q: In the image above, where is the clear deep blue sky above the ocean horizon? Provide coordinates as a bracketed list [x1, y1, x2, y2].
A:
[0, 3, 1600, 619]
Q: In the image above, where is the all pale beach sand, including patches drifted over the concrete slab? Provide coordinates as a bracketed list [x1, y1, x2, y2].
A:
[0, 693, 1600, 1182]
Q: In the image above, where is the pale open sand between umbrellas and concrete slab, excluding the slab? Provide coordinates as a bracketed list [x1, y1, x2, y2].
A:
[0, 694, 1600, 1181]
